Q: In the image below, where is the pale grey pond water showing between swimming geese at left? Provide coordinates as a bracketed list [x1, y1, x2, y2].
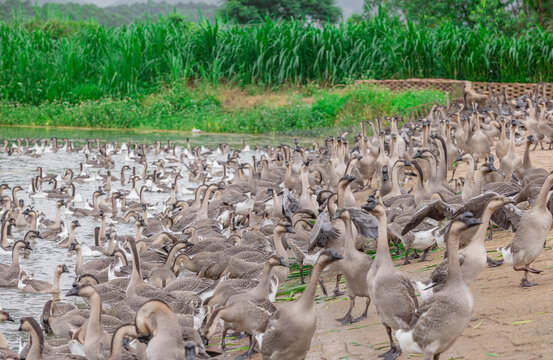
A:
[0, 127, 311, 349]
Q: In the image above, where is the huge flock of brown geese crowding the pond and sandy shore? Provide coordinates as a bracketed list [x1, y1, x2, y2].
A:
[0, 85, 553, 360]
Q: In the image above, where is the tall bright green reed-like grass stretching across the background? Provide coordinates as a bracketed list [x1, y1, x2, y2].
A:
[0, 15, 553, 105]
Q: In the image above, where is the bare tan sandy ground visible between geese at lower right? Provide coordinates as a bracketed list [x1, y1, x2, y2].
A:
[210, 143, 553, 360]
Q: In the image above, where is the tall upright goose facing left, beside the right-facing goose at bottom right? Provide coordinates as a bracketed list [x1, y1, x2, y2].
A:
[361, 191, 418, 360]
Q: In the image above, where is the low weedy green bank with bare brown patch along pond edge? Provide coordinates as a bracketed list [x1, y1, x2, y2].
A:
[0, 84, 444, 134]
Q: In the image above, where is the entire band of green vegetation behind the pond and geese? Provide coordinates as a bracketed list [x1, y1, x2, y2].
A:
[0, 0, 553, 133]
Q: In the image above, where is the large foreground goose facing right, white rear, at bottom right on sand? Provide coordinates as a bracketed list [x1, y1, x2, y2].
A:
[395, 212, 482, 360]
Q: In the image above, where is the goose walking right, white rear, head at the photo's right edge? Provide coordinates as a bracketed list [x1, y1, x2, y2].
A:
[497, 172, 553, 287]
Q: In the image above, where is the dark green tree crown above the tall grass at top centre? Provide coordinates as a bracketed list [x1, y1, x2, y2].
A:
[219, 0, 342, 24]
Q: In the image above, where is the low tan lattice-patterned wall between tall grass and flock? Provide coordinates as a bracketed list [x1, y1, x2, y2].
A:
[357, 79, 553, 100]
